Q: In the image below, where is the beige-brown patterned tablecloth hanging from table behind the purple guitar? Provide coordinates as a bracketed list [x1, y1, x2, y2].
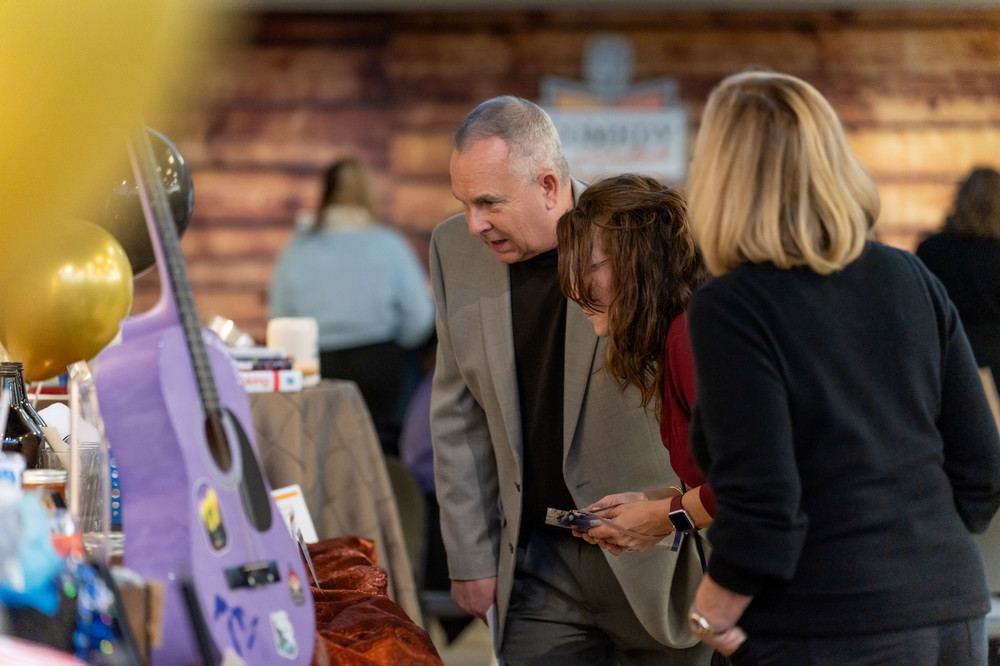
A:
[250, 379, 422, 624]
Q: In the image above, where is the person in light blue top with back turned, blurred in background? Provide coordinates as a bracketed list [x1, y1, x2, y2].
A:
[269, 158, 434, 453]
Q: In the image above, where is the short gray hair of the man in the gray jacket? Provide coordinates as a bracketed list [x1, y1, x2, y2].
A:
[455, 95, 569, 183]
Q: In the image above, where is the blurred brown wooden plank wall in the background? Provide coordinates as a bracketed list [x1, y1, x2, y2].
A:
[146, 10, 1000, 341]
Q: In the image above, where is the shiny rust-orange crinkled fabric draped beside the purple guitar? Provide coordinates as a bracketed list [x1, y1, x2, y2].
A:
[309, 537, 443, 666]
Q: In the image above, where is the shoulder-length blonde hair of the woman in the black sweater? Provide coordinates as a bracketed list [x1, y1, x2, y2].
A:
[689, 71, 879, 275]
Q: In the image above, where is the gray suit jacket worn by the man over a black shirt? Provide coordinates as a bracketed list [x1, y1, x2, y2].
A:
[430, 183, 701, 647]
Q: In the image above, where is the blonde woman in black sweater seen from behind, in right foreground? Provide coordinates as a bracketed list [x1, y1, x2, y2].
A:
[688, 72, 1000, 666]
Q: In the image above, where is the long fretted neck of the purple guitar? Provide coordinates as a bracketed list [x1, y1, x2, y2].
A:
[129, 128, 221, 413]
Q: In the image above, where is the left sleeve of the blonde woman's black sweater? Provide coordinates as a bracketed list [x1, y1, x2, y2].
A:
[688, 279, 808, 595]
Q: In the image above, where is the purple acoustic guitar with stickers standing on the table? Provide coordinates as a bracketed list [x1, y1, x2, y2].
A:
[94, 134, 315, 666]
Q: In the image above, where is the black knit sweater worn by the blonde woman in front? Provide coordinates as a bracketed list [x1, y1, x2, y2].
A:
[688, 243, 1000, 635]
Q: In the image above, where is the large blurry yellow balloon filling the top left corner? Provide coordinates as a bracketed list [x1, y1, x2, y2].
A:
[0, 0, 220, 240]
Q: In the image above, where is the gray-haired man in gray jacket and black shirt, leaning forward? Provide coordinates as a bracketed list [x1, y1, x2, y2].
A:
[430, 97, 710, 666]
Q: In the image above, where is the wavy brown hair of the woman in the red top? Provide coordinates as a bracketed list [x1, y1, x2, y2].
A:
[557, 174, 709, 416]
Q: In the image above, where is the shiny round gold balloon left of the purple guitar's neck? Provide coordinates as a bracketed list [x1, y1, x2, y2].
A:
[0, 220, 132, 381]
